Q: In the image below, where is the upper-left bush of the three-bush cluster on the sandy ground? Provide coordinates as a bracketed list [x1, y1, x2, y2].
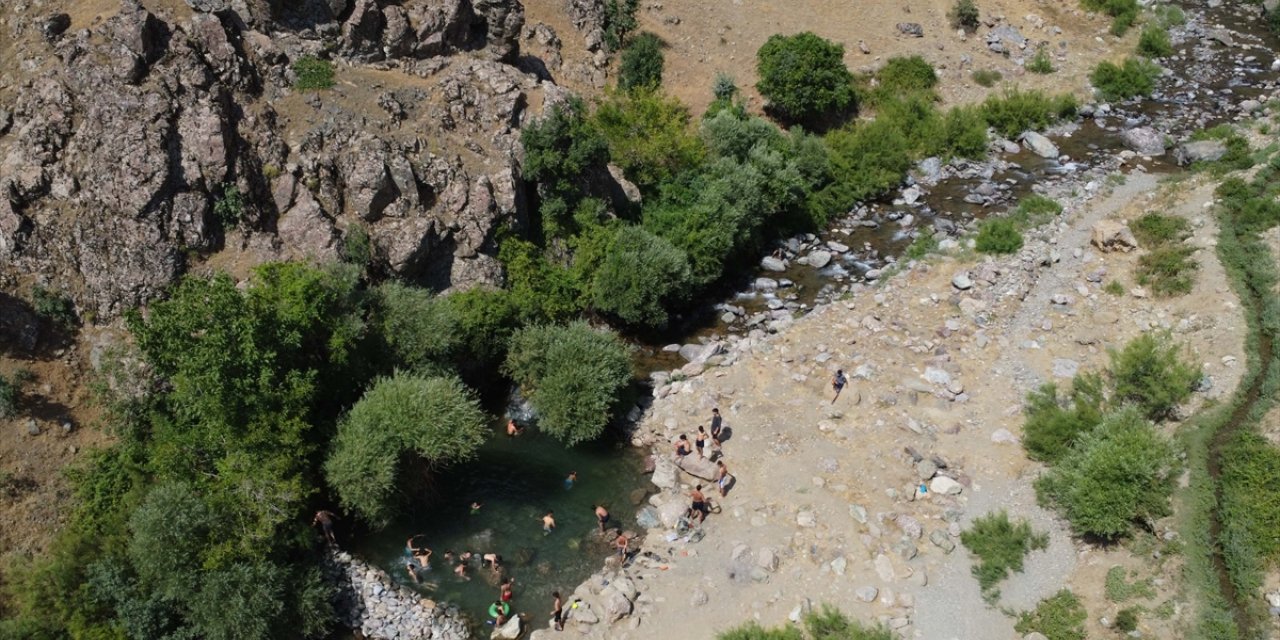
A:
[1023, 375, 1106, 463]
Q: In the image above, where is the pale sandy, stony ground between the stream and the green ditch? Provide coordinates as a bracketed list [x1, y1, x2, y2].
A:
[558, 174, 1245, 640]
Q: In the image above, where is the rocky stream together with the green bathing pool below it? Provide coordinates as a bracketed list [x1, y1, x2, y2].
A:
[356, 0, 1280, 628]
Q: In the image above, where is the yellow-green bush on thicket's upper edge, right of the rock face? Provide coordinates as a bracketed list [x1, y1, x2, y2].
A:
[594, 91, 707, 191]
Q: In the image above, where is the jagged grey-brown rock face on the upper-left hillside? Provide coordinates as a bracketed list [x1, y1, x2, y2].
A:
[0, 0, 535, 319]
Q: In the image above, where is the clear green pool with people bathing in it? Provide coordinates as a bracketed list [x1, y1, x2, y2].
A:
[357, 420, 646, 627]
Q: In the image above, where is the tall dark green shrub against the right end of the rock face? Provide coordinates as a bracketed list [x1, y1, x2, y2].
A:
[520, 97, 609, 237]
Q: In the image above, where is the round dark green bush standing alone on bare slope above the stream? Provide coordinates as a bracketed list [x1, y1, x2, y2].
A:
[755, 31, 856, 122]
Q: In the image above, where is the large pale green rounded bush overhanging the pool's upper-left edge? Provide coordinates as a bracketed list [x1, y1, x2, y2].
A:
[324, 372, 486, 527]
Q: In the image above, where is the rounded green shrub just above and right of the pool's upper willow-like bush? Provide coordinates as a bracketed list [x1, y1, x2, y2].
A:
[590, 224, 691, 326]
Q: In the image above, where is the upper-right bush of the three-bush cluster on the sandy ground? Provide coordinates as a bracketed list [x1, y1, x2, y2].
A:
[1108, 332, 1202, 420]
